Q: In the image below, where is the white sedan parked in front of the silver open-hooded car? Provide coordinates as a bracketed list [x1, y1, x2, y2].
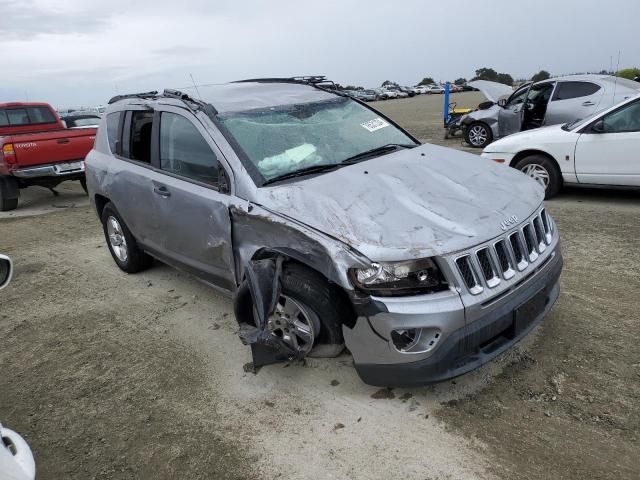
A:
[482, 95, 640, 198]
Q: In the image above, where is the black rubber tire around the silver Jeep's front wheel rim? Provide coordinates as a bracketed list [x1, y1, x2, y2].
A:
[234, 262, 353, 356]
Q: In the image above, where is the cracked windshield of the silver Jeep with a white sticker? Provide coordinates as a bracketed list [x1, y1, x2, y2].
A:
[219, 97, 416, 184]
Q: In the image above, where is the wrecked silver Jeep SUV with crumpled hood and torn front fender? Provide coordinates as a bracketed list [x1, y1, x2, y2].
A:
[86, 79, 562, 386]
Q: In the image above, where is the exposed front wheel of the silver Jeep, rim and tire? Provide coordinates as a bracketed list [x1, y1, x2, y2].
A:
[235, 262, 352, 356]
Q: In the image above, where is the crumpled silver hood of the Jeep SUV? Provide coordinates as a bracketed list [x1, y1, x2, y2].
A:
[256, 145, 544, 261]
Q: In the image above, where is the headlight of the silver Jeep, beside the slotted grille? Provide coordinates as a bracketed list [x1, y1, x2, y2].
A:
[349, 258, 449, 297]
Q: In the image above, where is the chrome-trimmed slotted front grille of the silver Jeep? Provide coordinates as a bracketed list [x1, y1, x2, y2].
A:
[455, 208, 554, 295]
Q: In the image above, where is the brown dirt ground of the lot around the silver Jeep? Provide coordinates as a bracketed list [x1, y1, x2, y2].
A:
[0, 93, 640, 480]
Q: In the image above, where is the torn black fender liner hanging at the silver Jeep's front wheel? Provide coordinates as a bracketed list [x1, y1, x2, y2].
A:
[235, 256, 304, 371]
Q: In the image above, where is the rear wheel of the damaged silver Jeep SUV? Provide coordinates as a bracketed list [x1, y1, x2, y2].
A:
[102, 202, 153, 273]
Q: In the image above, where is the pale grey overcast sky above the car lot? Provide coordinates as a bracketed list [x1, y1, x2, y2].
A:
[0, 0, 640, 107]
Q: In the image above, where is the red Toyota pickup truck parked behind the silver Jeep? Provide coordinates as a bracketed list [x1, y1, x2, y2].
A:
[0, 103, 97, 211]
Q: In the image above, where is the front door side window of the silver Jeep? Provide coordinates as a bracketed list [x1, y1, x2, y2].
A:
[160, 112, 220, 185]
